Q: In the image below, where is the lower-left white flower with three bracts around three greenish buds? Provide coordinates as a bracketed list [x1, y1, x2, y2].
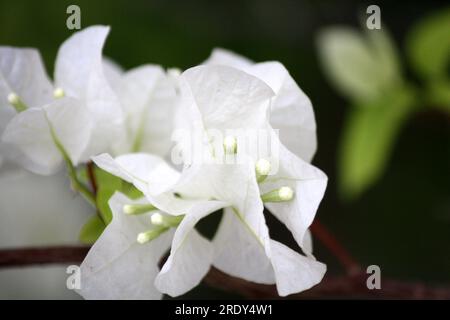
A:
[79, 154, 226, 299]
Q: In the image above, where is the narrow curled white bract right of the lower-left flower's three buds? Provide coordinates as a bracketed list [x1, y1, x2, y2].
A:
[155, 201, 223, 297]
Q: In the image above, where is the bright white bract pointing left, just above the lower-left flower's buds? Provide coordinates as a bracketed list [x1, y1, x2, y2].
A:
[92, 153, 179, 196]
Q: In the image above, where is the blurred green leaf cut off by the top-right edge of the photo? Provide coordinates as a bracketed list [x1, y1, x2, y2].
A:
[407, 8, 450, 78]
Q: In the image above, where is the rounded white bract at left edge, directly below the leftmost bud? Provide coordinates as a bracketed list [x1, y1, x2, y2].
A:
[2, 108, 62, 174]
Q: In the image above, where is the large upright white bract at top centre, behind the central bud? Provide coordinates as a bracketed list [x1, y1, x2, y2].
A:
[172, 66, 274, 164]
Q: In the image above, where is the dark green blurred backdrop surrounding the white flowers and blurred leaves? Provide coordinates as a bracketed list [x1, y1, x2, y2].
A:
[0, 0, 450, 298]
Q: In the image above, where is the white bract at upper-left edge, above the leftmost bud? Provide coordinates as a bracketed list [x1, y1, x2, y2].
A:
[0, 47, 53, 109]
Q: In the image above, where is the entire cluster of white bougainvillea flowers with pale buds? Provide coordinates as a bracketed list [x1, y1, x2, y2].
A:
[0, 26, 327, 299]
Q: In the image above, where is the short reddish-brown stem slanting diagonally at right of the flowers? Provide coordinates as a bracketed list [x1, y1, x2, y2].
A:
[310, 219, 361, 276]
